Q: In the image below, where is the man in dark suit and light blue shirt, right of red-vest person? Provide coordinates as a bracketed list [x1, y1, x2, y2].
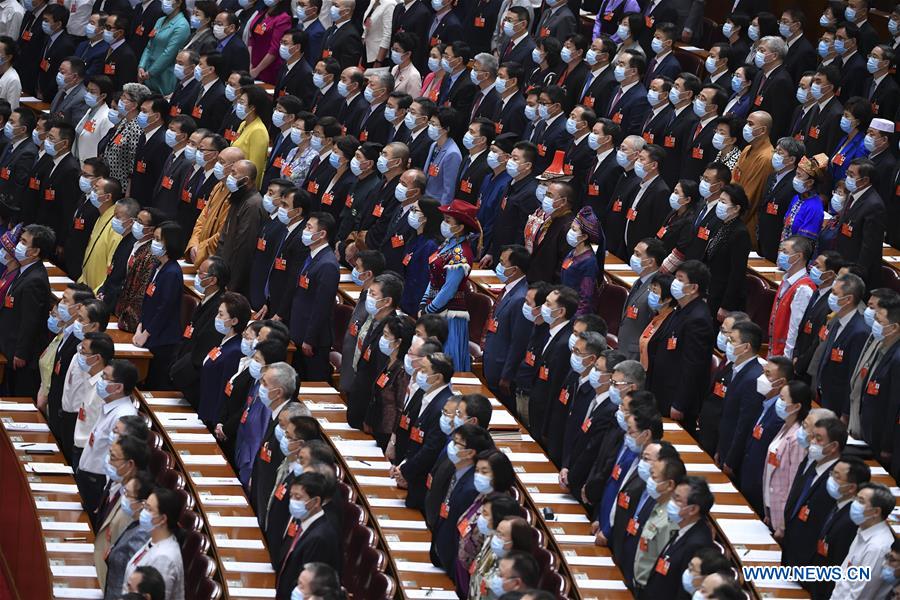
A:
[816, 273, 870, 415]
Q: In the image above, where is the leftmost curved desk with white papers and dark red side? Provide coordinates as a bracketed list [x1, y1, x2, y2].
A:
[0, 398, 103, 600]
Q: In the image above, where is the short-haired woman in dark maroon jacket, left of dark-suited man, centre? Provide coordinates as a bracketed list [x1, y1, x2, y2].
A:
[363, 314, 415, 450]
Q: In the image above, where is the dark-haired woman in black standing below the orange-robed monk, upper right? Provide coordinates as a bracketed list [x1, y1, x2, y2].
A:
[703, 184, 750, 323]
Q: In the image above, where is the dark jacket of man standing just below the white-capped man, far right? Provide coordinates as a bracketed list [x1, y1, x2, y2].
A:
[835, 186, 885, 287]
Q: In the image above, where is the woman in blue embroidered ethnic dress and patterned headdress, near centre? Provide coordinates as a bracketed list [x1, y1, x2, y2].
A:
[560, 206, 603, 317]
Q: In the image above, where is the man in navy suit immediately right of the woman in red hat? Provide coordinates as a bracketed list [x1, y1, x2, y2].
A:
[482, 245, 531, 407]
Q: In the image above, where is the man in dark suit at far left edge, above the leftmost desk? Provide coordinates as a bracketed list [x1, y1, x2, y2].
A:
[0, 225, 56, 398]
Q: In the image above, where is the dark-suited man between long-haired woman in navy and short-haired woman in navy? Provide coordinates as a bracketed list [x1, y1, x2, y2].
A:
[169, 256, 231, 407]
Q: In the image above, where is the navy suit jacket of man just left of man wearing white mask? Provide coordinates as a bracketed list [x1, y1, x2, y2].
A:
[716, 357, 763, 476]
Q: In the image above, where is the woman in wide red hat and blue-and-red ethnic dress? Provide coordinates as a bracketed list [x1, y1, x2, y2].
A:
[419, 200, 481, 372]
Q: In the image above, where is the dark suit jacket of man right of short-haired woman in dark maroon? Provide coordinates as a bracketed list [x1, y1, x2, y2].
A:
[398, 386, 453, 510]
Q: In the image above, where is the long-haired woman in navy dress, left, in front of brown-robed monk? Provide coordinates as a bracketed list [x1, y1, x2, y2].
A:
[133, 221, 185, 390]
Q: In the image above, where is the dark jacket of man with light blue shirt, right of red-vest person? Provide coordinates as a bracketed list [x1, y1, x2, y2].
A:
[816, 313, 871, 415]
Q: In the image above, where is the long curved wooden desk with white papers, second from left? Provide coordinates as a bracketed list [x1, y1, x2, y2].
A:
[135, 390, 275, 598]
